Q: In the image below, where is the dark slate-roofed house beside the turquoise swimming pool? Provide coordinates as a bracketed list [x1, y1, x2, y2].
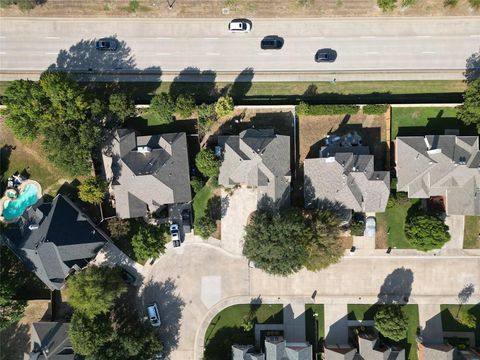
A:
[3, 195, 109, 290]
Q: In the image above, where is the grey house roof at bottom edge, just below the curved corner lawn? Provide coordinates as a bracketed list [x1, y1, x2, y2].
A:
[232, 336, 313, 360]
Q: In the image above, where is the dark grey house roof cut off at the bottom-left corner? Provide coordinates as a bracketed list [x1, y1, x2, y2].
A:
[30, 322, 77, 360]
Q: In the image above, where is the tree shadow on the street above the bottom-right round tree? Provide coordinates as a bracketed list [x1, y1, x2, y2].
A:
[377, 267, 413, 304]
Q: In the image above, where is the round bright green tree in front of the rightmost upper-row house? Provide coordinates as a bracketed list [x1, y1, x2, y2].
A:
[405, 211, 450, 251]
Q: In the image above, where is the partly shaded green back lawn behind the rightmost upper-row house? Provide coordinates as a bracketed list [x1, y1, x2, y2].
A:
[392, 107, 477, 139]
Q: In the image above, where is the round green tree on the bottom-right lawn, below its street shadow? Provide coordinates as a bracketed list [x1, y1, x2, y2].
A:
[374, 305, 408, 341]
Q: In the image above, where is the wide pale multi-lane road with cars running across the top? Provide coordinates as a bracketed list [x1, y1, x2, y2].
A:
[0, 17, 480, 80]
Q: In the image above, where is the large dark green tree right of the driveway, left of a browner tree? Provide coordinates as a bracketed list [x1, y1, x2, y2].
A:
[243, 208, 313, 276]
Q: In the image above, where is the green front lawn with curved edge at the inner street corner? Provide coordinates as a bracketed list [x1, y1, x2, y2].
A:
[204, 304, 283, 360]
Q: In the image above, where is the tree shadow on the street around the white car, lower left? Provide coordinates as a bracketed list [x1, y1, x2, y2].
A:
[141, 278, 188, 358]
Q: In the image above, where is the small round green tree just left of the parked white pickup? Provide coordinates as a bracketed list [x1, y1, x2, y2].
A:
[132, 225, 167, 261]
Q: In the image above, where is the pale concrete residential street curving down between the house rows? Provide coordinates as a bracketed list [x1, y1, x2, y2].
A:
[142, 241, 480, 360]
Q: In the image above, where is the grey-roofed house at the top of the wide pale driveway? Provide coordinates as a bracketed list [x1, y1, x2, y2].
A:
[218, 129, 291, 206]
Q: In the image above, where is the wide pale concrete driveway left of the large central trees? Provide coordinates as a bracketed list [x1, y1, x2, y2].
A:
[222, 187, 258, 255]
